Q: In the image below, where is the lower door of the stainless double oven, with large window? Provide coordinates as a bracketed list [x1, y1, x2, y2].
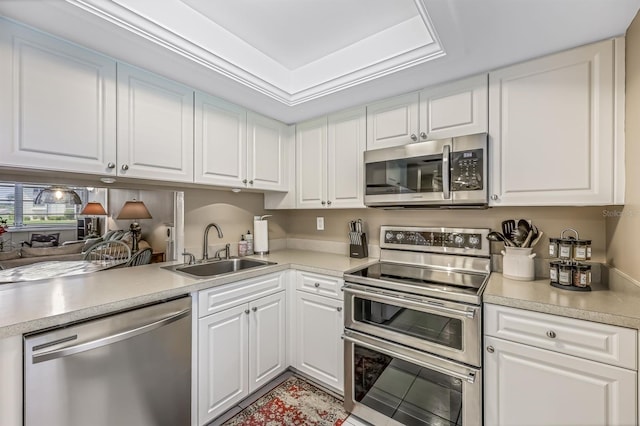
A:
[344, 330, 482, 426]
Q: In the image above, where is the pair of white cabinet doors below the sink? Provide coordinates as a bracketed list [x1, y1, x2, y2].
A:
[197, 284, 287, 425]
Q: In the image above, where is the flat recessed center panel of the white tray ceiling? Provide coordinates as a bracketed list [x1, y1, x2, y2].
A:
[182, 0, 418, 71]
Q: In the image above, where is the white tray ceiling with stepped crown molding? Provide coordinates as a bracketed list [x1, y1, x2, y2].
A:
[0, 0, 640, 122]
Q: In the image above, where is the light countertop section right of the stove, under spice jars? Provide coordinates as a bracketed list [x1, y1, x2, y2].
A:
[483, 272, 640, 330]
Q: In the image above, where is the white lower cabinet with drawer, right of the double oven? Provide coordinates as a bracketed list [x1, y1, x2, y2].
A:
[484, 305, 637, 426]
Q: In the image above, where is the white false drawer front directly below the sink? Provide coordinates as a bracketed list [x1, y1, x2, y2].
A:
[198, 272, 286, 318]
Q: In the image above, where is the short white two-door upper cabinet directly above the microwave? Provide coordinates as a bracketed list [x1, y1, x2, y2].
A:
[367, 74, 488, 150]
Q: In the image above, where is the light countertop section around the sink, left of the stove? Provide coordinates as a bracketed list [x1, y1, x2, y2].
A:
[0, 250, 377, 338]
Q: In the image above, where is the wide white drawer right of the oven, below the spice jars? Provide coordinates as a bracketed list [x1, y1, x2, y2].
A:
[484, 304, 637, 370]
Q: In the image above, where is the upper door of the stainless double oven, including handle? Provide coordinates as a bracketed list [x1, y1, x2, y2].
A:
[344, 283, 482, 366]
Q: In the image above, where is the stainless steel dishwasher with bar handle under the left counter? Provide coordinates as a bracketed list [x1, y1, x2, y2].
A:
[24, 297, 191, 426]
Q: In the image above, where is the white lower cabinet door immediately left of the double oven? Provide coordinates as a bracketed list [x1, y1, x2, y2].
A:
[296, 291, 344, 392]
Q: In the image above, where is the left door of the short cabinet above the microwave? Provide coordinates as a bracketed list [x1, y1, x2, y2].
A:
[367, 93, 420, 150]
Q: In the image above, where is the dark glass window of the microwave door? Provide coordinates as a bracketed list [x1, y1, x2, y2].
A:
[365, 155, 443, 195]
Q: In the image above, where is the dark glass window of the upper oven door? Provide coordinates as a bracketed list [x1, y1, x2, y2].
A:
[353, 297, 463, 350]
